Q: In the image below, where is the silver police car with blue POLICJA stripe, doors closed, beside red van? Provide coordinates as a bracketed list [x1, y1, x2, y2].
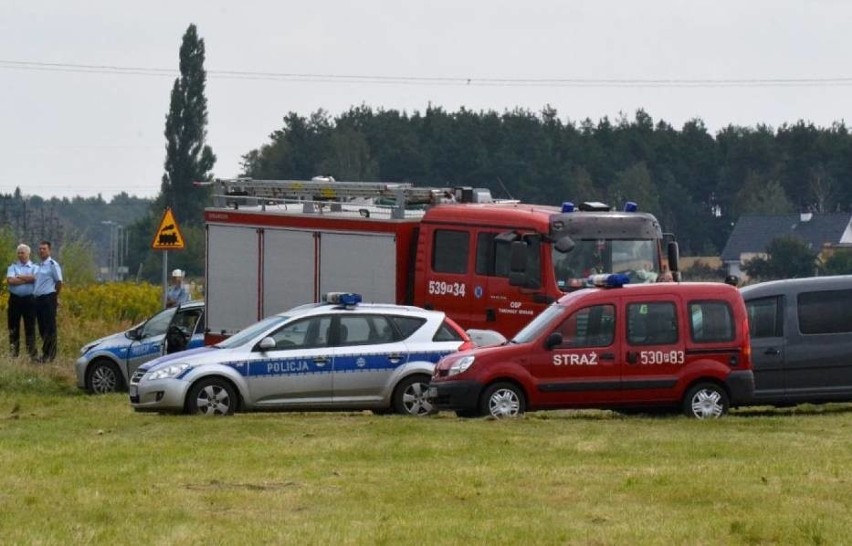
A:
[130, 292, 473, 415]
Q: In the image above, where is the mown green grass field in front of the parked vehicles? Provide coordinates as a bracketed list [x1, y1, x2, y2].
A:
[0, 359, 852, 545]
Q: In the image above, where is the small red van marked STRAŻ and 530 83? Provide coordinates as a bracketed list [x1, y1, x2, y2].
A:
[429, 275, 754, 419]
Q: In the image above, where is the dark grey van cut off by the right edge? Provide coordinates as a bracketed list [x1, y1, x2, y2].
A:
[741, 275, 852, 406]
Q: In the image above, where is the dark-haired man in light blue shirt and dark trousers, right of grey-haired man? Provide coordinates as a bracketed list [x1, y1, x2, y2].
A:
[33, 241, 62, 362]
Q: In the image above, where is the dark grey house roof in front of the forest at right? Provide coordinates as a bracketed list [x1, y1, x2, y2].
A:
[721, 213, 852, 262]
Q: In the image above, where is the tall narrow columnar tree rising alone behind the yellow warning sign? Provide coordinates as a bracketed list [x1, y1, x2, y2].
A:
[154, 24, 216, 226]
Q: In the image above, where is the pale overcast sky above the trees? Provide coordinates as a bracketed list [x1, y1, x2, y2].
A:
[0, 0, 852, 200]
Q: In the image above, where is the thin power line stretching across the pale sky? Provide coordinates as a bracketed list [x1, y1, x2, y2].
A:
[0, 59, 852, 88]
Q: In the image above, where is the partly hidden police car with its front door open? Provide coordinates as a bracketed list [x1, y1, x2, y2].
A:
[75, 301, 204, 394]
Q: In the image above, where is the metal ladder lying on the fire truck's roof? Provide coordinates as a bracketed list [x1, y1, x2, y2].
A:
[204, 178, 460, 218]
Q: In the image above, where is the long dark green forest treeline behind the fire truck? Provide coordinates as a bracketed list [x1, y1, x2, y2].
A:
[243, 106, 852, 255]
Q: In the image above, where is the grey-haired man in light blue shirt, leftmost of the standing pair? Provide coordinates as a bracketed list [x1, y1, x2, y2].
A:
[6, 244, 38, 359]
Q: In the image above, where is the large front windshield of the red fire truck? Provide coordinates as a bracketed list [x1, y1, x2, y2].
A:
[551, 239, 660, 292]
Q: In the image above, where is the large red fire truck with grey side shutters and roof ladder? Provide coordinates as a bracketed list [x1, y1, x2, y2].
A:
[205, 178, 677, 343]
